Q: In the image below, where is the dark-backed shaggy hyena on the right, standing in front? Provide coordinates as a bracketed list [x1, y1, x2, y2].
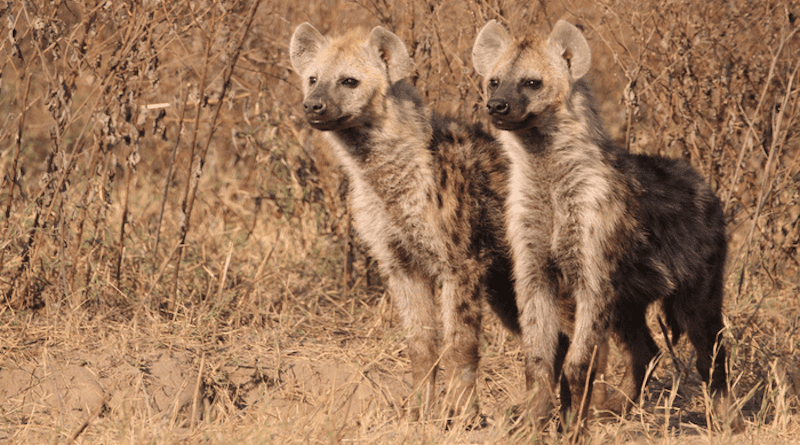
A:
[472, 20, 741, 429]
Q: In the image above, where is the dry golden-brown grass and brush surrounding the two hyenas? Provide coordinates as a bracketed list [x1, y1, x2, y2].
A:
[0, 0, 800, 444]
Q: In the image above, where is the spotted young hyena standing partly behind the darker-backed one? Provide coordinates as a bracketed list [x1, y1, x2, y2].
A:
[289, 23, 519, 416]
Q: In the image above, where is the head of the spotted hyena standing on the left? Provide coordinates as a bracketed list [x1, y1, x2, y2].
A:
[289, 23, 412, 130]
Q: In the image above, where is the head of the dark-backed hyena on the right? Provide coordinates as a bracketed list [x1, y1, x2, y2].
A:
[472, 20, 591, 131]
